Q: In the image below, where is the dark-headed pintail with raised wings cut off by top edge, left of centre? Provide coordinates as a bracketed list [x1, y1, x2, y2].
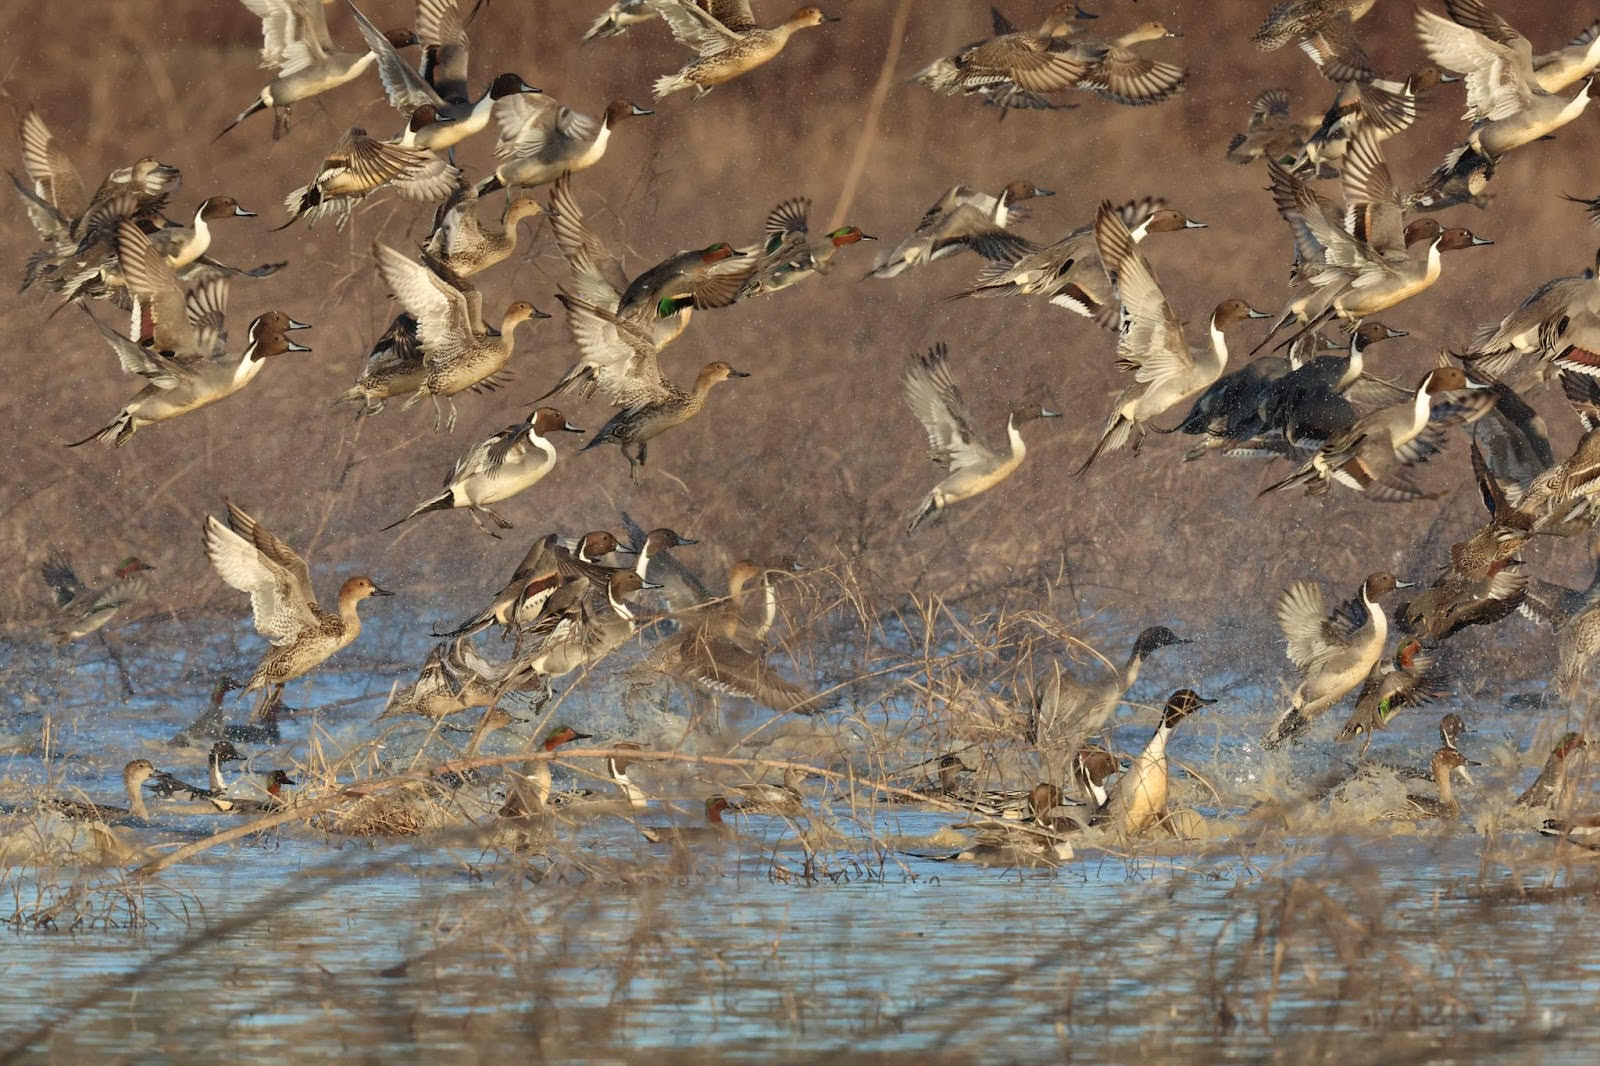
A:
[347, 0, 539, 149]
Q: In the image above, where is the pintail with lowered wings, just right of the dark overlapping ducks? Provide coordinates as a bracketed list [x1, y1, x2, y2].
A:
[1261, 367, 1496, 503]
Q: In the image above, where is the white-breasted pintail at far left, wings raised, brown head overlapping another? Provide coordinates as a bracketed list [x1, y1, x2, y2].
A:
[67, 284, 312, 448]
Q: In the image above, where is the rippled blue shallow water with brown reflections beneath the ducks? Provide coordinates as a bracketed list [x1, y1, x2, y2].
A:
[0, 627, 1600, 1063]
